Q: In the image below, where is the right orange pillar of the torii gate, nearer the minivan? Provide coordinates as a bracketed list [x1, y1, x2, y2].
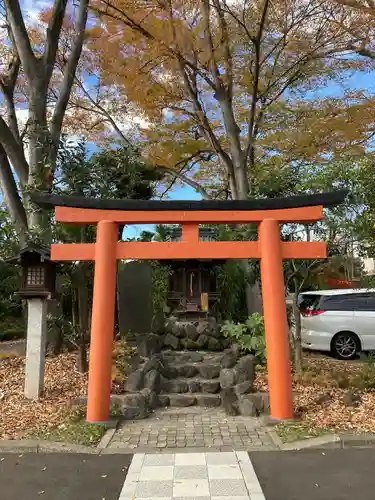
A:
[259, 219, 294, 420]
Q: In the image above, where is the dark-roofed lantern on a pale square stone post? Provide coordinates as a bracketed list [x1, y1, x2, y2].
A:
[7, 243, 56, 399]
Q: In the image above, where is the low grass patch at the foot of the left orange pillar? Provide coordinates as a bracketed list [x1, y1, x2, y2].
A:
[27, 408, 107, 446]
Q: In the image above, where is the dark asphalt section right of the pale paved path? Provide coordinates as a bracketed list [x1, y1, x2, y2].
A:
[249, 448, 375, 500]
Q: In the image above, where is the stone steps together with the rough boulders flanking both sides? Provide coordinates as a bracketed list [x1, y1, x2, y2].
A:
[111, 342, 268, 420]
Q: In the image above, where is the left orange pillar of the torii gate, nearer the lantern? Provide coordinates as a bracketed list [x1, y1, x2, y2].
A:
[87, 221, 118, 422]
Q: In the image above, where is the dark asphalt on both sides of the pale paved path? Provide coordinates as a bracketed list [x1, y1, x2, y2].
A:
[0, 449, 375, 500]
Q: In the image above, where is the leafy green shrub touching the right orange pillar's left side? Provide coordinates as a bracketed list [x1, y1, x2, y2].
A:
[221, 313, 266, 365]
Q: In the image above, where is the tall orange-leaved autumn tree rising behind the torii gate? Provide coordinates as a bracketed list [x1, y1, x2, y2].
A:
[89, 0, 374, 199]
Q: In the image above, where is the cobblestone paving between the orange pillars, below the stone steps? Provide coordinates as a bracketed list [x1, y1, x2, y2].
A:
[109, 408, 275, 452]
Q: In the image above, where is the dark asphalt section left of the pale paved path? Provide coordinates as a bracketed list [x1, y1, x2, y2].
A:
[0, 453, 132, 500]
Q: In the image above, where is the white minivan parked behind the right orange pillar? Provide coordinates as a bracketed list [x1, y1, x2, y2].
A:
[298, 289, 375, 359]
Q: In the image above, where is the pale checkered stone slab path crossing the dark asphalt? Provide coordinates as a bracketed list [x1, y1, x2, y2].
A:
[119, 451, 265, 500]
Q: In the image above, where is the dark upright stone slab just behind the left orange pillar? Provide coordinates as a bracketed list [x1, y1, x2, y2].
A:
[117, 261, 153, 334]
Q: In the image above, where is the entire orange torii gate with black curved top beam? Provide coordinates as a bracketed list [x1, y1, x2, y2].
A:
[32, 191, 347, 422]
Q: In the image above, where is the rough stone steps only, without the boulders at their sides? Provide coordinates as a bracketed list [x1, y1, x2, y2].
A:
[159, 351, 224, 407]
